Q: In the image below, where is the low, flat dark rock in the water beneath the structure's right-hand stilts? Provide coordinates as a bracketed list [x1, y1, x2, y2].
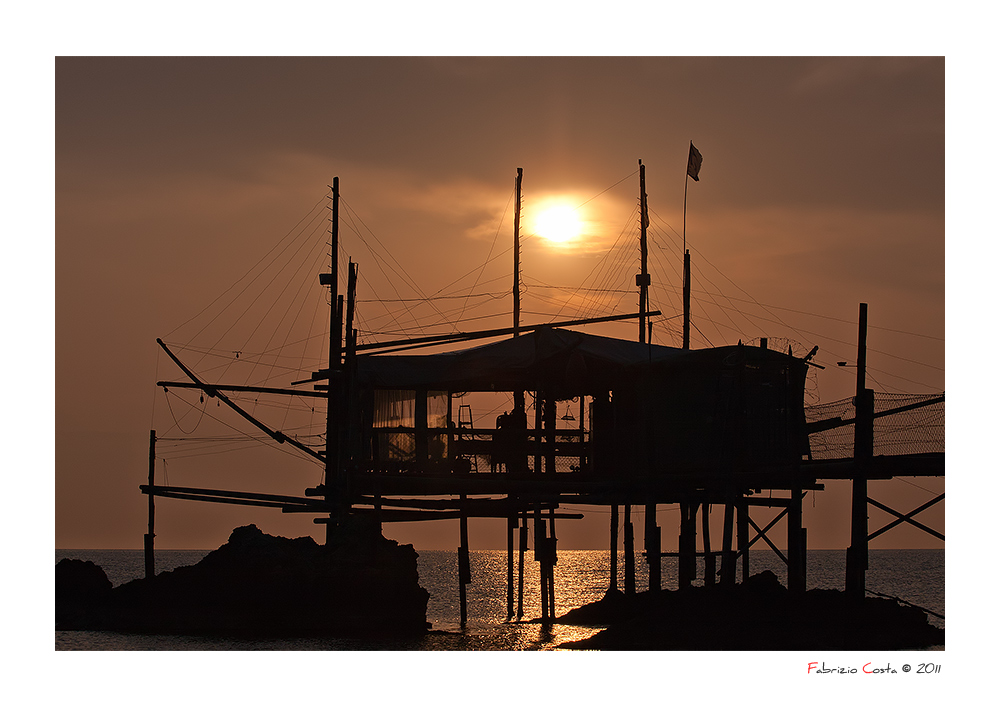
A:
[558, 571, 944, 650]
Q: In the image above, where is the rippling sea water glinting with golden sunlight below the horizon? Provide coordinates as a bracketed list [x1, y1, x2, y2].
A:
[55, 550, 945, 651]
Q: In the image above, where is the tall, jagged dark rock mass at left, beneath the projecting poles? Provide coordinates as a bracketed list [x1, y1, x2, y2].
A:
[56, 519, 429, 636]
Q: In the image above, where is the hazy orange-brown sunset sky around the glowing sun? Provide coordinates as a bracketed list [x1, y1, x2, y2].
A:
[55, 57, 945, 549]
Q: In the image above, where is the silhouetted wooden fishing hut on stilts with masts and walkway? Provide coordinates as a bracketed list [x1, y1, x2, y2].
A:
[140, 155, 944, 623]
